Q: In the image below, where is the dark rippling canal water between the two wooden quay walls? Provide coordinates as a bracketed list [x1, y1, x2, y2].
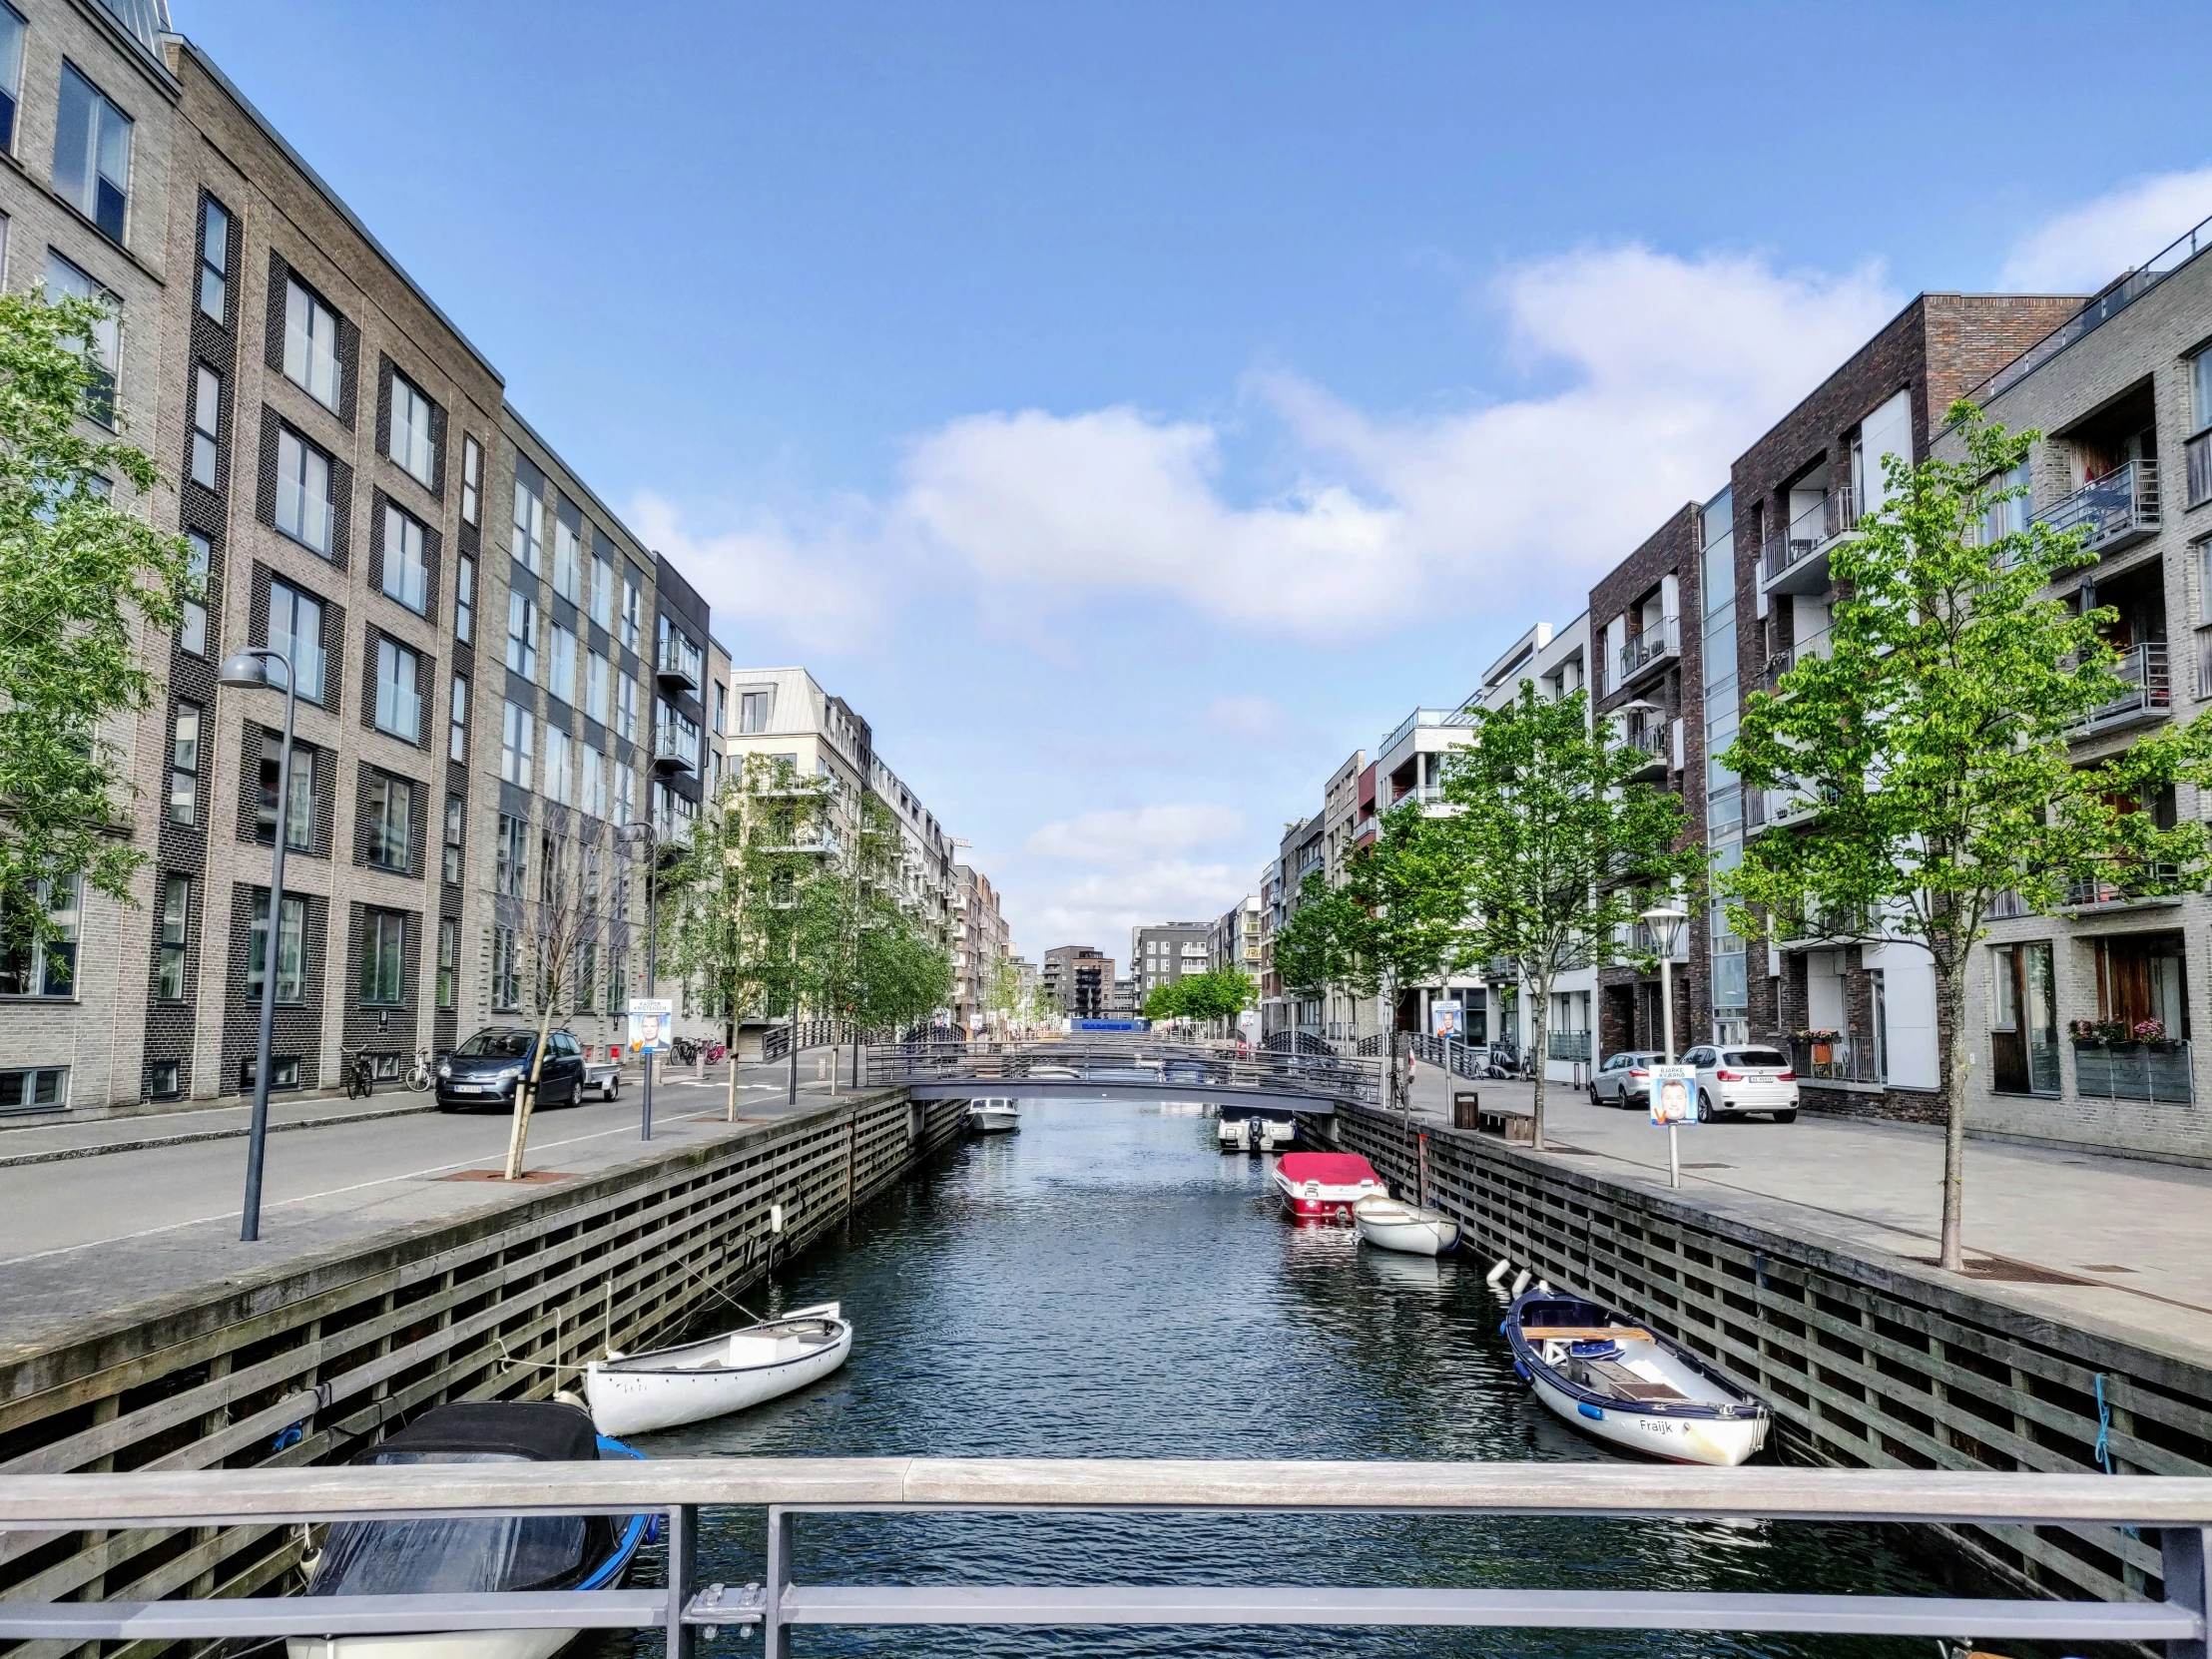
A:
[615, 1102, 1942, 1659]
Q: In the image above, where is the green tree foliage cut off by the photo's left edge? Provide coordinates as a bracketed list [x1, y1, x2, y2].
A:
[0, 292, 193, 955]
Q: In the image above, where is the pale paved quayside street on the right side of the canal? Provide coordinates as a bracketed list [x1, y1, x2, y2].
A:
[1415, 1066, 2212, 1363]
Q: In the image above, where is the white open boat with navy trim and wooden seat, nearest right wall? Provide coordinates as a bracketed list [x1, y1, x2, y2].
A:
[1504, 1283, 1768, 1466]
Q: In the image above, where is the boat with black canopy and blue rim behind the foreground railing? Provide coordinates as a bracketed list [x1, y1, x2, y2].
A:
[285, 1400, 651, 1659]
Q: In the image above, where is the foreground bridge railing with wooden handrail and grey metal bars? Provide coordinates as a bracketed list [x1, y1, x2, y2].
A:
[0, 1457, 2212, 1659]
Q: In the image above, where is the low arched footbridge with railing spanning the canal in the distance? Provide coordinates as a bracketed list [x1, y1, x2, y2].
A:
[864, 1040, 1382, 1106]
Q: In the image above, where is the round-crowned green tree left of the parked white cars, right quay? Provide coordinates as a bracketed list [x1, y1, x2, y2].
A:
[1437, 679, 1701, 1148]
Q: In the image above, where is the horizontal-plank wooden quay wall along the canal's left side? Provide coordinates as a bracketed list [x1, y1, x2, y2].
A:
[0, 1090, 964, 1659]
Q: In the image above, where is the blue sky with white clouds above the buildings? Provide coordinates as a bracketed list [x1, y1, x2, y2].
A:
[186, 0, 2212, 955]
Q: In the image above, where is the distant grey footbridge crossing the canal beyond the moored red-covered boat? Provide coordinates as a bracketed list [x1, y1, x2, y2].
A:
[862, 1037, 1382, 1113]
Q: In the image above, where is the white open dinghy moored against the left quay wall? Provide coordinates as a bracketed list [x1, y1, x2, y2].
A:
[584, 1303, 851, 1433]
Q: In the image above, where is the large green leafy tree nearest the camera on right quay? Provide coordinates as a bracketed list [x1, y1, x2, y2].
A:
[1721, 402, 2212, 1272]
